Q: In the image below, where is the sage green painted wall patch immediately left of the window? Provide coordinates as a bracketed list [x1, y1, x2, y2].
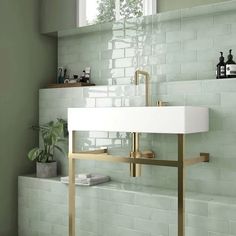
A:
[40, 0, 76, 33]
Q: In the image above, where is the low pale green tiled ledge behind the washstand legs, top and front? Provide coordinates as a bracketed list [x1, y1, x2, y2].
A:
[19, 177, 236, 236]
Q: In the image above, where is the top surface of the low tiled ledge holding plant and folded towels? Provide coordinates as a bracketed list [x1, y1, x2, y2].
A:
[19, 175, 236, 205]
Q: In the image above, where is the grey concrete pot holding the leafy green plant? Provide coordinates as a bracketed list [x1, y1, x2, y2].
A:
[36, 161, 57, 178]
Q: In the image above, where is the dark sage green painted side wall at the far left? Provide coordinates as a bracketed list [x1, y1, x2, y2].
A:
[0, 0, 57, 236]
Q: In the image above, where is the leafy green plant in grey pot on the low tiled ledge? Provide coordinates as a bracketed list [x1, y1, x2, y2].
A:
[28, 119, 67, 178]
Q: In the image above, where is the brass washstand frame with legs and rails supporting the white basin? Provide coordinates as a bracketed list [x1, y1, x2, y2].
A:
[69, 70, 209, 236]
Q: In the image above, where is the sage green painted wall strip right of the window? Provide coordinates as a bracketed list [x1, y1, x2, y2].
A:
[157, 0, 228, 12]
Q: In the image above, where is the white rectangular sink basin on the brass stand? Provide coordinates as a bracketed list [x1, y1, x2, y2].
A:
[68, 106, 209, 134]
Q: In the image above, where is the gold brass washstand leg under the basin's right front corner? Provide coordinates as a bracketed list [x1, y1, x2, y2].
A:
[178, 134, 185, 236]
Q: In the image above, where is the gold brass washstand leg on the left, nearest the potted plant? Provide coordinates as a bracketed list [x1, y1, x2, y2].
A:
[69, 131, 75, 236]
